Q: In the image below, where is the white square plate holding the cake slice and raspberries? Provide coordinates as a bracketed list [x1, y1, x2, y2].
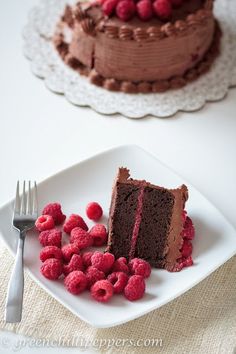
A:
[0, 146, 236, 328]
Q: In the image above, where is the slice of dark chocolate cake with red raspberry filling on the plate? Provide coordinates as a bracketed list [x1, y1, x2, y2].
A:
[107, 168, 192, 271]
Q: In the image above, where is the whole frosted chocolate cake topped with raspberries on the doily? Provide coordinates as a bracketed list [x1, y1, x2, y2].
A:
[54, 0, 220, 93]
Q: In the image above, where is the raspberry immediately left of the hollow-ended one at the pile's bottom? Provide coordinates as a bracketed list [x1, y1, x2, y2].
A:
[64, 270, 88, 295]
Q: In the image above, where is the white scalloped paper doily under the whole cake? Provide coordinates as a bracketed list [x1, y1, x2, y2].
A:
[23, 0, 236, 118]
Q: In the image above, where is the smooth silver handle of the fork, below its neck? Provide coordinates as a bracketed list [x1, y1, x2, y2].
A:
[5, 233, 25, 323]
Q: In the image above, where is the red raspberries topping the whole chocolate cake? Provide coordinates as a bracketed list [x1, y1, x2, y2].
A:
[98, 0, 186, 21]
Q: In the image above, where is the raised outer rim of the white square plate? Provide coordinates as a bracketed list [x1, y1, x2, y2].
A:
[0, 144, 236, 328]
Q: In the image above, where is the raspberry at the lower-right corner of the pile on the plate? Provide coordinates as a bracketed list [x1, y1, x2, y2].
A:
[124, 275, 145, 301]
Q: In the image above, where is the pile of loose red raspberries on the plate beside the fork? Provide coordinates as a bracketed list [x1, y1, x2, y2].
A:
[35, 202, 151, 302]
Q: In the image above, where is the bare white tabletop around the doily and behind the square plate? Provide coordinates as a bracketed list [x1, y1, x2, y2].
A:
[0, 0, 236, 353]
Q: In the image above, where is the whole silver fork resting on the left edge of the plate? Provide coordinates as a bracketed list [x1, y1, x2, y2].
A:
[5, 181, 38, 323]
